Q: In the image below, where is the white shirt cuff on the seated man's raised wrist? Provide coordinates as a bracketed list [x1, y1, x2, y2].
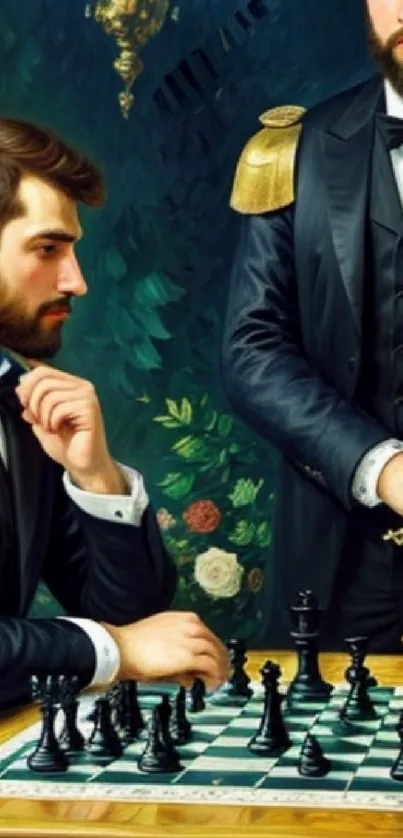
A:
[63, 463, 149, 527]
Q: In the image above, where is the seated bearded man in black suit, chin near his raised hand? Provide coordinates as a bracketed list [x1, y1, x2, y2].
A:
[0, 119, 228, 705]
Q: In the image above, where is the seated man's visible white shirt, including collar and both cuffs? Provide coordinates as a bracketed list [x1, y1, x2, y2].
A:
[0, 353, 148, 686]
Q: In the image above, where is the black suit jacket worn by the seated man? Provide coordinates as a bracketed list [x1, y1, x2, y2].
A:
[0, 388, 176, 706]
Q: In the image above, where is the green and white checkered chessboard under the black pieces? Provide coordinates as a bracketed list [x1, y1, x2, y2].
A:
[0, 684, 403, 811]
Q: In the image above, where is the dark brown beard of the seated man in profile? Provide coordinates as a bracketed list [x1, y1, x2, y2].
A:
[0, 296, 62, 360]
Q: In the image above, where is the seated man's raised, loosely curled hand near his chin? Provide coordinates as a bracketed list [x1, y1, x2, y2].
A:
[16, 365, 127, 494]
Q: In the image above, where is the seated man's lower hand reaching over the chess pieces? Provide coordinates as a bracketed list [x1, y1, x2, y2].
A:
[102, 611, 229, 689]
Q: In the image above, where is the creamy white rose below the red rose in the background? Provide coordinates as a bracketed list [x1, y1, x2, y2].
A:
[194, 547, 244, 599]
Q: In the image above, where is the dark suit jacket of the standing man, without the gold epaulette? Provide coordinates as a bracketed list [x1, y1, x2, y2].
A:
[223, 77, 390, 616]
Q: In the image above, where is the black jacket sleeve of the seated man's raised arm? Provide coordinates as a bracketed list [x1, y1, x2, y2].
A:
[43, 470, 176, 625]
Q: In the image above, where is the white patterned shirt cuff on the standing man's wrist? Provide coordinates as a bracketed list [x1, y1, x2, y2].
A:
[351, 439, 403, 508]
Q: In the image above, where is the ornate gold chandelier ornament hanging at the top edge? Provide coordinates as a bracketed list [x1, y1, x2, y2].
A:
[85, 0, 171, 119]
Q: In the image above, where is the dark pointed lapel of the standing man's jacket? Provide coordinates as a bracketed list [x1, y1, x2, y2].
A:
[322, 77, 383, 335]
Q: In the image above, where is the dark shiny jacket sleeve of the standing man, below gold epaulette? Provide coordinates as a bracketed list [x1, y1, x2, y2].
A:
[222, 213, 390, 508]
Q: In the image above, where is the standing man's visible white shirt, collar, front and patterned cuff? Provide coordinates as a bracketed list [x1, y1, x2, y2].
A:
[352, 81, 403, 507]
